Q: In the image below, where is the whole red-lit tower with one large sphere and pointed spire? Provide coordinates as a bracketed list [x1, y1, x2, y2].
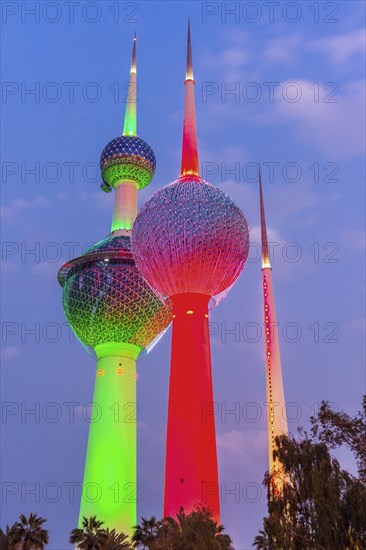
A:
[132, 22, 249, 520]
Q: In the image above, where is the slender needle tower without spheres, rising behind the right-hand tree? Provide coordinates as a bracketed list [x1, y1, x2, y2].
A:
[258, 166, 288, 490]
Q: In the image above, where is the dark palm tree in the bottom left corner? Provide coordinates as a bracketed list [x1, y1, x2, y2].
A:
[6, 514, 49, 550]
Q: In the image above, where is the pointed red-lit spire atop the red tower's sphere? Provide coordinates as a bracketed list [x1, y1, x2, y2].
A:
[180, 19, 199, 178]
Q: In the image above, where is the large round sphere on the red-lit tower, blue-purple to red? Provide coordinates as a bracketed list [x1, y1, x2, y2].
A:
[132, 176, 249, 297]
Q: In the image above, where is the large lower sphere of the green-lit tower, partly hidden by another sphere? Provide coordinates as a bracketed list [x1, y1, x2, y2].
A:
[58, 236, 172, 349]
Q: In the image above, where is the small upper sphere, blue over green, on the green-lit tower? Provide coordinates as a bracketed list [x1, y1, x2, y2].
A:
[100, 136, 156, 189]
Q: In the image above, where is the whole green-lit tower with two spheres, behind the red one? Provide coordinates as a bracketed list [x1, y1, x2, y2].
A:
[58, 38, 171, 534]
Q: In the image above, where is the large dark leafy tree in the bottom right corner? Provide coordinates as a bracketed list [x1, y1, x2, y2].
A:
[254, 396, 366, 550]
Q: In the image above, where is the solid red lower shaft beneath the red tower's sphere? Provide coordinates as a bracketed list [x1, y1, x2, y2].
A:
[164, 293, 220, 521]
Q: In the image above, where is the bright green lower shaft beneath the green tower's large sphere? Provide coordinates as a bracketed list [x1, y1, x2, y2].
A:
[79, 343, 140, 535]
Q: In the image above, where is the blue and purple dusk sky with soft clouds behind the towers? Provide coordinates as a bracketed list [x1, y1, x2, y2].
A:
[0, 0, 365, 550]
